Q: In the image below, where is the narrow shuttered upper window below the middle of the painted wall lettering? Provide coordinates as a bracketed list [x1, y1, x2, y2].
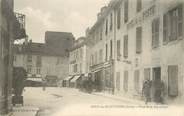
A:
[136, 27, 142, 54]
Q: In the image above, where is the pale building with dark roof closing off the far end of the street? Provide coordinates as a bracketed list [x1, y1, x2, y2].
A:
[14, 32, 74, 86]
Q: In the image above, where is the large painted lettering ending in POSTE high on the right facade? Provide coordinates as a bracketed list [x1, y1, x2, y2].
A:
[127, 5, 155, 29]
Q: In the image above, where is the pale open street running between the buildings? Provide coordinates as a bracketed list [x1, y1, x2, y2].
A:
[23, 88, 183, 116]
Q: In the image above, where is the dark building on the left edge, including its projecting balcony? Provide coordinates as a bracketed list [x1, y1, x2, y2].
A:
[0, 0, 26, 115]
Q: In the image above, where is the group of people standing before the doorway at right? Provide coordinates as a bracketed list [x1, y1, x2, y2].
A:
[142, 79, 164, 104]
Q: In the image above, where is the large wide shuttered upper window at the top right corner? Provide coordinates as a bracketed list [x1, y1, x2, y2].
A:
[163, 5, 183, 44]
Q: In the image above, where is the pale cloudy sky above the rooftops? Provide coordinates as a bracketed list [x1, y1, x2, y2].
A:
[14, 0, 110, 42]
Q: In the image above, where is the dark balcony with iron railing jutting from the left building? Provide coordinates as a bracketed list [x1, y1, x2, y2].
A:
[13, 13, 27, 40]
